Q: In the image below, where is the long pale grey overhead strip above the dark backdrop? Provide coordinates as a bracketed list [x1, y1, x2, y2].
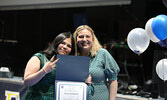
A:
[0, 0, 131, 10]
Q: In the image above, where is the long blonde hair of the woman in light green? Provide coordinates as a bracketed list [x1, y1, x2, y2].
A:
[73, 25, 102, 57]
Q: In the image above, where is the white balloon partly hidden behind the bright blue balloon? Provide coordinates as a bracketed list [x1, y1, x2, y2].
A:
[145, 18, 160, 43]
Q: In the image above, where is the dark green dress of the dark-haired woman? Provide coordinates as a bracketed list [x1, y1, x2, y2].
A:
[23, 53, 56, 100]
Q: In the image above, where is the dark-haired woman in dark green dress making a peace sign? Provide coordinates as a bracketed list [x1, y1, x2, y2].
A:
[23, 32, 72, 100]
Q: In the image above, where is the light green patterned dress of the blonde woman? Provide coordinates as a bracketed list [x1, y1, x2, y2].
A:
[89, 48, 120, 100]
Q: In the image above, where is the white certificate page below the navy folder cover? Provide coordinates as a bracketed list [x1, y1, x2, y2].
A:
[55, 81, 88, 100]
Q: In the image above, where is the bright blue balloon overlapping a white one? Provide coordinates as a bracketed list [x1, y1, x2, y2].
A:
[151, 15, 167, 40]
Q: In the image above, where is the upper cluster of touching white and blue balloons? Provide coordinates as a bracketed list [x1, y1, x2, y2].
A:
[127, 14, 167, 55]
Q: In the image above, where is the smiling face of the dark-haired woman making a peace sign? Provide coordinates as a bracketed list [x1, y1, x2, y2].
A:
[57, 38, 72, 55]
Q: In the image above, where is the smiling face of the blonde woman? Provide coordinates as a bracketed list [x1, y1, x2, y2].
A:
[77, 29, 93, 52]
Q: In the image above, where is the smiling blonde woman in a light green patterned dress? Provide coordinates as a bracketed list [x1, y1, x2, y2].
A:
[73, 25, 119, 100]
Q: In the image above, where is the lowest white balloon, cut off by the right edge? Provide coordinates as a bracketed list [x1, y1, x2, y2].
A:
[156, 59, 167, 80]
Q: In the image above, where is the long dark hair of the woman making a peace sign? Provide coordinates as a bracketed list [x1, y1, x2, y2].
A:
[42, 32, 72, 59]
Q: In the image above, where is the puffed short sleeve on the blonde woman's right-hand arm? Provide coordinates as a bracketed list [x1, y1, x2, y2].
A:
[103, 49, 120, 80]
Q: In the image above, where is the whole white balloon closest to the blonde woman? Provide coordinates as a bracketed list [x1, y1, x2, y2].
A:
[127, 28, 150, 54]
